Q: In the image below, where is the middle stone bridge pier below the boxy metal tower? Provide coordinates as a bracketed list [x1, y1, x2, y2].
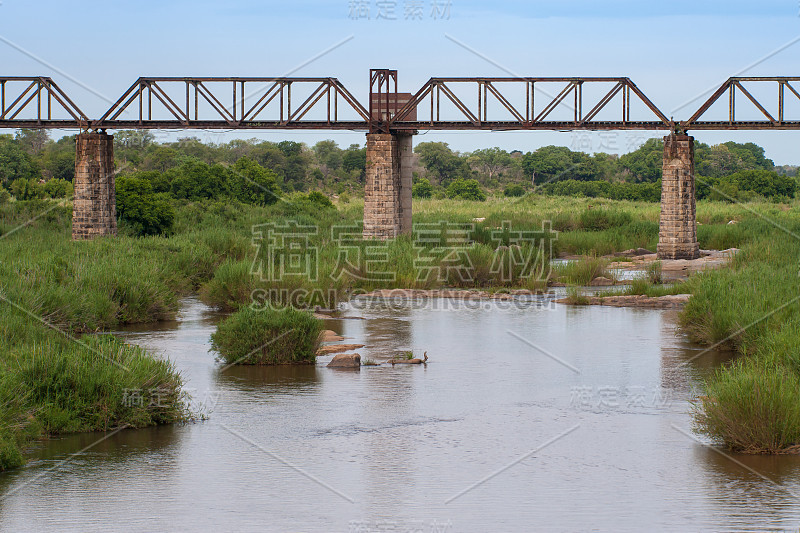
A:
[363, 133, 413, 240]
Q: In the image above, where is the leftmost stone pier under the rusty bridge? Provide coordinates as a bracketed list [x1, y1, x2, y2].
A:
[72, 133, 117, 240]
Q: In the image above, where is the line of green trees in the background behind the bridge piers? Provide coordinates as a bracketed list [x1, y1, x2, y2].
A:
[0, 130, 797, 212]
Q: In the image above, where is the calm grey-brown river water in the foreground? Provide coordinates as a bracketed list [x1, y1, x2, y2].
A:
[0, 297, 800, 532]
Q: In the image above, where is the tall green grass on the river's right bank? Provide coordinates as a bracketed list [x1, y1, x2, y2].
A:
[681, 214, 800, 453]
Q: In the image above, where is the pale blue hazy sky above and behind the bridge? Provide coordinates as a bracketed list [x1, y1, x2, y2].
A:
[0, 0, 800, 164]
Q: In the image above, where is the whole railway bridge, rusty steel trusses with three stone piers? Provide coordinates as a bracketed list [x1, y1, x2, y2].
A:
[0, 69, 800, 259]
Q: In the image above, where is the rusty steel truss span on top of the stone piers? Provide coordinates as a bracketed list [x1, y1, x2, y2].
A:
[0, 69, 800, 133]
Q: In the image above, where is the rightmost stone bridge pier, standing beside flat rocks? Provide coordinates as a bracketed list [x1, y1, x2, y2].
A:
[657, 133, 700, 259]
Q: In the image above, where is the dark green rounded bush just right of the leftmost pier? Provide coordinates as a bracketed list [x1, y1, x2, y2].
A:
[116, 176, 175, 236]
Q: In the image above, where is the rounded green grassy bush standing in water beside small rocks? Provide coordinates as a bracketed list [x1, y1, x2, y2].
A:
[211, 307, 322, 365]
